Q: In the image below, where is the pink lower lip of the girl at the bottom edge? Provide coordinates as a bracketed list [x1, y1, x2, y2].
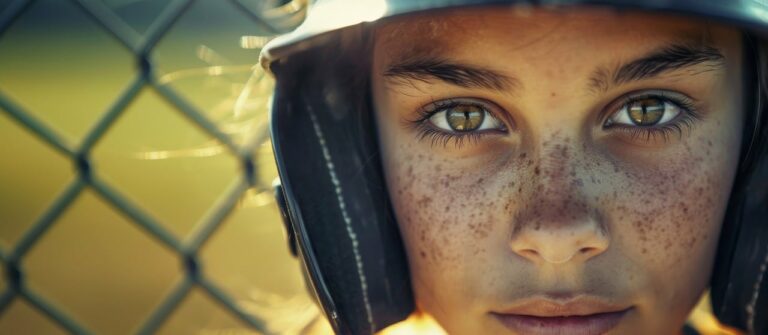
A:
[494, 309, 629, 335]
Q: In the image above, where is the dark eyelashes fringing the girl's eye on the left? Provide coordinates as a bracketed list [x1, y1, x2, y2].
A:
[407, 99, 507, 149]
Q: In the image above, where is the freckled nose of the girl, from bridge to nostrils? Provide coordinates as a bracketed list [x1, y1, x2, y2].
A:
[510, 133, 608, 263]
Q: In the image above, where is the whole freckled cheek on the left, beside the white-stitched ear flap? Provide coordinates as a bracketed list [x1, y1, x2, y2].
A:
[387, 146, 510, 321]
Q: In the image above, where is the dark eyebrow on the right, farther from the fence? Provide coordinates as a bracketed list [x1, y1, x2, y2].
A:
[589, 44, 725, 92]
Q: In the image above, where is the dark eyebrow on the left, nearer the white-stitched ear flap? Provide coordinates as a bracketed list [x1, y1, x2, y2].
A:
[384, 57, 520, 91]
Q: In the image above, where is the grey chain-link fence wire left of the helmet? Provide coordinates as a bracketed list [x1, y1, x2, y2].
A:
[0, 0, 306, 334]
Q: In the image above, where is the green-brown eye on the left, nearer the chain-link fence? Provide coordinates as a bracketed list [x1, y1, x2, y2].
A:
[427, 103, 504, 133]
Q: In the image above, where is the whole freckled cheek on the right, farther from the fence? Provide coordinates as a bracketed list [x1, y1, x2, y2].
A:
[602, 136, 738, 308]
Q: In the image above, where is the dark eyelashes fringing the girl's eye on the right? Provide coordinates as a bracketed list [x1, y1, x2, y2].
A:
[603, 91, 701, 143]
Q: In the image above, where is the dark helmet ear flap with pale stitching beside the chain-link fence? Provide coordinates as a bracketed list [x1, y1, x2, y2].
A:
[270, 44, 414, 334]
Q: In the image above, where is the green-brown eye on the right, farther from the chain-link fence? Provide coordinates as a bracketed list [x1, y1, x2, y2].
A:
[607, 97, 682, 127]
